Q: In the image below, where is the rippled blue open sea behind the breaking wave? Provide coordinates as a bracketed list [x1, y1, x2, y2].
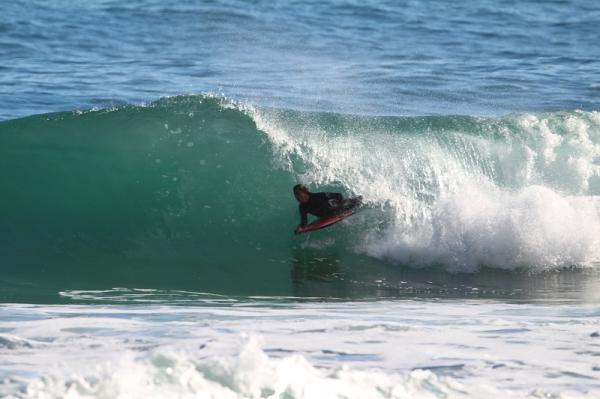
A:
[0, 0, 600, 119]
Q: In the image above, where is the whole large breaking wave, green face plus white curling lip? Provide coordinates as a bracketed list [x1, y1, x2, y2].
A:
[0, 95, 600, 294]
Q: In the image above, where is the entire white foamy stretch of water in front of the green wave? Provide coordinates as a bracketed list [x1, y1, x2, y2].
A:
[0, 296, 600, 398]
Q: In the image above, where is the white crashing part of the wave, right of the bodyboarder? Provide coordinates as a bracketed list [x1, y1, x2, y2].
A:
[254, 103, 600, 271]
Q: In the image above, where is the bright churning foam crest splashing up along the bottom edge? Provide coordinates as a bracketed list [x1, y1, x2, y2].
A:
[18, 338, 489, 399]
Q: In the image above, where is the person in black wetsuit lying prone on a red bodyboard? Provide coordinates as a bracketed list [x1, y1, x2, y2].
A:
[294, 184, 362, 233]
